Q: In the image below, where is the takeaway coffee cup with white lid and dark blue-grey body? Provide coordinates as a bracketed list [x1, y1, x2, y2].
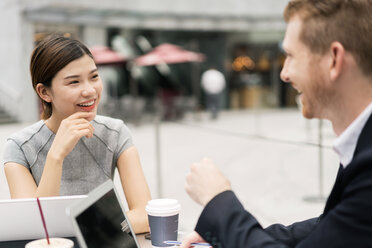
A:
[146, 199, 181, 248]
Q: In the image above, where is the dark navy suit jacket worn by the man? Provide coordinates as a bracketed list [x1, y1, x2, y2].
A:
[195, 114, 372, 248]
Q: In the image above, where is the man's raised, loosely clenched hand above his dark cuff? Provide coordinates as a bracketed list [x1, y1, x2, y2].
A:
[185, 158, 231, 206]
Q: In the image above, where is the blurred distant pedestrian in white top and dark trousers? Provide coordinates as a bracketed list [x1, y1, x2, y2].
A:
[201, 67, 226, 119]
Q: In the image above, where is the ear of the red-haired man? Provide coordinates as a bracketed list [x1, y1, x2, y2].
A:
[330, 41, 345, 81]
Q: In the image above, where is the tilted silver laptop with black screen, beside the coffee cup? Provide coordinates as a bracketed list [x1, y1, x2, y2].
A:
[67, 180, 140, 248]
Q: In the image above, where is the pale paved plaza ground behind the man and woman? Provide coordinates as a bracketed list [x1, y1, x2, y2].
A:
[0, 109, 338, 231]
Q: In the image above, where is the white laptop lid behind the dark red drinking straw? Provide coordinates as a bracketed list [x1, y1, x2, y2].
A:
[0, 195, 86, 241]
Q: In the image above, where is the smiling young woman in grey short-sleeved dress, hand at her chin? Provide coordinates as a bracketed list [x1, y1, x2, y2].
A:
[4, 35, 151, 233]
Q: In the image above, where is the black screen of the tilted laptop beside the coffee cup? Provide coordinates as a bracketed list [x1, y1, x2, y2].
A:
[75, 189, 137, 248]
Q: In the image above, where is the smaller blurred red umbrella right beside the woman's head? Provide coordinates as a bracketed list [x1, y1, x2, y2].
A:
[90, 46, 126, 65]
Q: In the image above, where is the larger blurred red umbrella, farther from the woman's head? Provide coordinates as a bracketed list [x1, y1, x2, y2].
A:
[134, 43, 205, 66]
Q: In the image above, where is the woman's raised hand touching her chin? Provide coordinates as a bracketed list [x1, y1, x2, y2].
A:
[48, 112, 94, 161]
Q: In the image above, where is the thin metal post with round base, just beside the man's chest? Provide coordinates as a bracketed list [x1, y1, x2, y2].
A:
[304, 119, 326, 202]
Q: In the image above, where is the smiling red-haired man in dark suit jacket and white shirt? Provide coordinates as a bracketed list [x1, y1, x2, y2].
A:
[181, 0, 372, 248]
